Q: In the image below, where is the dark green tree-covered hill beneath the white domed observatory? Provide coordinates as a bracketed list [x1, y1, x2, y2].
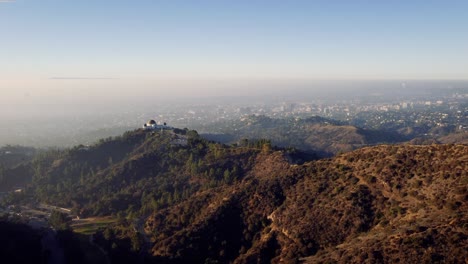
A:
[6, 129, 286, 216]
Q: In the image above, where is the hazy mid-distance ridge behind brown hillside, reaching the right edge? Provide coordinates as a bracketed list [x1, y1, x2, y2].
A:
[200, 115, 468, 157]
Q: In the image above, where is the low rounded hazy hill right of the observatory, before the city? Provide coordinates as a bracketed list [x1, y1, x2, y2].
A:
[199, 116, 408, 157]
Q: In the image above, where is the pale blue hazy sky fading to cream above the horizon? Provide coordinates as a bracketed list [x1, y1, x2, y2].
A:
[0, 0, 468, 103]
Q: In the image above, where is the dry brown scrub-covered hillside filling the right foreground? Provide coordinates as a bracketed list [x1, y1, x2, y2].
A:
[140, 145, 468, 263]
